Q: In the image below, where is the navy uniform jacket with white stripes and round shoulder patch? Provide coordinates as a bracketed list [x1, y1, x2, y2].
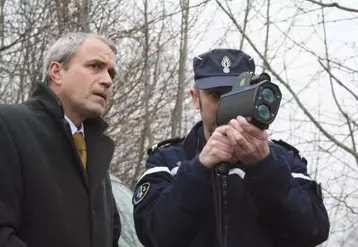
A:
[133, 122, 330, 247]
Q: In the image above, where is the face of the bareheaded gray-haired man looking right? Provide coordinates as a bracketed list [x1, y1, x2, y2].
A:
[50, 39, 116, 119]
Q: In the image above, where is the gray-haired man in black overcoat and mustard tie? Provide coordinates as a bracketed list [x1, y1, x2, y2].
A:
[0, 33, 120, 247]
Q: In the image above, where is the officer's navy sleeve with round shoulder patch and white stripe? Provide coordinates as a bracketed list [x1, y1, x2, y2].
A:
[133, 151, 212, 247]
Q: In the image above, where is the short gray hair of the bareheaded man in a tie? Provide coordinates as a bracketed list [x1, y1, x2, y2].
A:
[42, 32, 117, 84]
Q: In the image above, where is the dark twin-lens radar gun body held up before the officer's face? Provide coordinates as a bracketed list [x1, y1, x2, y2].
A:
[216, 72, 282, 129]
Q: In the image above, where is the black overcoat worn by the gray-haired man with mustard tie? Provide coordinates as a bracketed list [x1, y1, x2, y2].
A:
[0, 84, 120, 247]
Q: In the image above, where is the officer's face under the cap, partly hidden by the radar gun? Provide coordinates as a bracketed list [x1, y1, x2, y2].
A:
[190, 87, 231, 139]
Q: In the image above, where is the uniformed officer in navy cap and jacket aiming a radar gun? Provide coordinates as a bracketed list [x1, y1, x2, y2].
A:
[133, 49, 329, 247]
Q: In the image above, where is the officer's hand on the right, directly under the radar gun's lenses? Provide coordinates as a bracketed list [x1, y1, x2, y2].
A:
[226, 116, 270, 165]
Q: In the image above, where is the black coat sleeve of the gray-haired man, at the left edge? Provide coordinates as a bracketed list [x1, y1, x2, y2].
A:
[0, 117, 26, 247]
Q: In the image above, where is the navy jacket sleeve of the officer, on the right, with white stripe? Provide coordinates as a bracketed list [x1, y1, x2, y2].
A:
[244, 144, 330, 247]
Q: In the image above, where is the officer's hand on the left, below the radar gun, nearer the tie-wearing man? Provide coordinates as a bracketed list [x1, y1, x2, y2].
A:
[199, 125, 234, 168]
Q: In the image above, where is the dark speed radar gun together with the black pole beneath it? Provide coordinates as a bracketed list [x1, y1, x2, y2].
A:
[213, 72, 282, 247]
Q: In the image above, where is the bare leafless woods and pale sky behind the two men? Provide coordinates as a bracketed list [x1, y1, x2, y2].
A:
[0, 0, 358, 244]
